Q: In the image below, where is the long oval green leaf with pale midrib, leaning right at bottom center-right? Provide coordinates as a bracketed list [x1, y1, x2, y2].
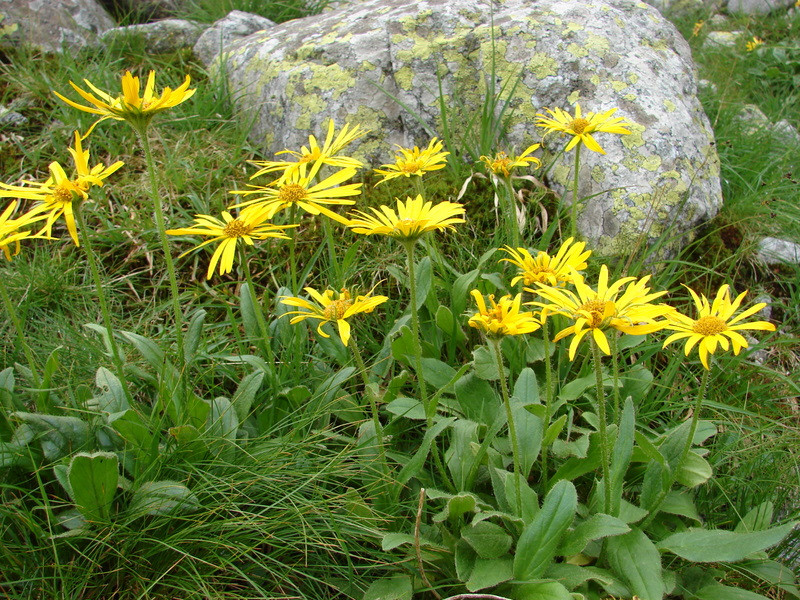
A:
[514, 480, 578, 580]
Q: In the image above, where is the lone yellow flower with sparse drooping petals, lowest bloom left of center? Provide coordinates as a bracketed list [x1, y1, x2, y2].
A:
[281, 287, 389, 346]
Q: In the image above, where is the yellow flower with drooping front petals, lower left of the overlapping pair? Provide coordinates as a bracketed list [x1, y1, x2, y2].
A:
[167, 206, 295, 279]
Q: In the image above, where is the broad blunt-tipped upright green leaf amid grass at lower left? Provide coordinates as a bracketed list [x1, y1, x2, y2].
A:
[67, 452, 119, 523]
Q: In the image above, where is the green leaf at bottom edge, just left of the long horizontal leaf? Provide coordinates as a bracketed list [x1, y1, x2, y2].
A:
[606, 528, 666, 600]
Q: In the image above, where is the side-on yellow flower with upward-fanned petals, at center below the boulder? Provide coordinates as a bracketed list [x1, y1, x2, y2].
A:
[347, 195, 465, 242]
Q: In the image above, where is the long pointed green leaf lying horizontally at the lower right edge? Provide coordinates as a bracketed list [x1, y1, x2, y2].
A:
[658, 522, 797, 562]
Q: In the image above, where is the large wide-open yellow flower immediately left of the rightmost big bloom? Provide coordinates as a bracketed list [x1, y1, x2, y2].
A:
[530, 265, 674, 360]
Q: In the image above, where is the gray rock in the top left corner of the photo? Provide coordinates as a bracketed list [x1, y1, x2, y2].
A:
[0, 0, 116, 52]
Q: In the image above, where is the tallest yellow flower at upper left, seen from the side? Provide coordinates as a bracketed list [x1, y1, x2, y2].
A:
[53, 71, 195, 132]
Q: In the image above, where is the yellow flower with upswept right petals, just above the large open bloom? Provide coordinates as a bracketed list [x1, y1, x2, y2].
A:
[500, 238, 592, 294]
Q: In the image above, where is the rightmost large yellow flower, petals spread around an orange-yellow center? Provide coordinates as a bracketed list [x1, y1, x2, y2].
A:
[664, 285, 775, 369]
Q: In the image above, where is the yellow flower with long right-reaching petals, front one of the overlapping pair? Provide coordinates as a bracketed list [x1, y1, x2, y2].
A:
[231, 168, 362, 225]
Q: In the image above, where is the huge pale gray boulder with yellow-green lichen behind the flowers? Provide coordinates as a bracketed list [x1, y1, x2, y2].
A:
[220, 0, 722, 254]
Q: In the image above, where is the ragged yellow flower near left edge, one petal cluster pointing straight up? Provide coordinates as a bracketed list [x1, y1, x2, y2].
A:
[0, 131, 125, 246]
